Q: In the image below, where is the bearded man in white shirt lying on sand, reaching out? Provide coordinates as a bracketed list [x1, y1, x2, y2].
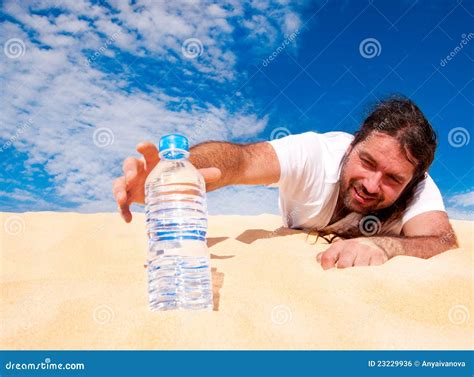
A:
[113, 97, 457, 269]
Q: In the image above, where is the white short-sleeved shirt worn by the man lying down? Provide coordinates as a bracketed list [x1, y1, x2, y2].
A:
[269, 132, 445, 234]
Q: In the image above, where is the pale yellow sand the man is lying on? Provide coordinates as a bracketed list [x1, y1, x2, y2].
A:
[0, 212, 474, 350]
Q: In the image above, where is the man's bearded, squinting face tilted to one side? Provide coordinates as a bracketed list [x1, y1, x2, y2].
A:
[340, 132, 414, 213]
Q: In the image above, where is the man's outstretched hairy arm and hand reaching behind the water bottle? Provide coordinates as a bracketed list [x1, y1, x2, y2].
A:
[113, 141, 280, 222]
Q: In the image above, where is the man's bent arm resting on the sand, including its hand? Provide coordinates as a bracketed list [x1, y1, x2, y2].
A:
[317, 211, 458, 269]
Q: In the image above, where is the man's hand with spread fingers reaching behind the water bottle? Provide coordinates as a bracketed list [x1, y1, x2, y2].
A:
[113, 142, 221, 223]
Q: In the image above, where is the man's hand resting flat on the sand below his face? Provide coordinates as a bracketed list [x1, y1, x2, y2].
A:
[316, 238, 391, 270]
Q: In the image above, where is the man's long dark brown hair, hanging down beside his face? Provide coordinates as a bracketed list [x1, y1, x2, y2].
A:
[317, 95, 437, 241]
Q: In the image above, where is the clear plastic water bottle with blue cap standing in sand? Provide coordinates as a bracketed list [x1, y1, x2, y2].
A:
[145, 134, 212, 310]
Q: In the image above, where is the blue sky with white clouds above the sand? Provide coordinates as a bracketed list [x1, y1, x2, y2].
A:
[0, 0, 474, 219]
